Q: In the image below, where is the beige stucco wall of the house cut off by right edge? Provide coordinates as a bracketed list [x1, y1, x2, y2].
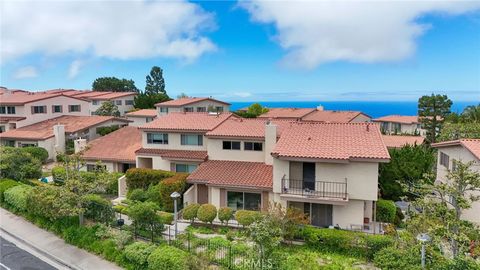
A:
[437, 145, 480, 223]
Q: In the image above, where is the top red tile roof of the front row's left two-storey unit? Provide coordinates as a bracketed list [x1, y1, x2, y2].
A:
[140, 113, 232, 132]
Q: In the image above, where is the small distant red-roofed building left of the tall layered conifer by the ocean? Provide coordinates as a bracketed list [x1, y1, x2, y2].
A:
[373, 115, 426, 136]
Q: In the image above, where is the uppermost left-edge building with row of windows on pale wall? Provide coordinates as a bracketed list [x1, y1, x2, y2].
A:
[0, 91, 89, 132]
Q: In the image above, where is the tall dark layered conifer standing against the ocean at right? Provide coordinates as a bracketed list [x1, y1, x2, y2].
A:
[418, 94, 452, 143]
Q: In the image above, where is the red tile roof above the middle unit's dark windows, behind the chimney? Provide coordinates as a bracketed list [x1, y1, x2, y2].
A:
[206, 117, 292, 139]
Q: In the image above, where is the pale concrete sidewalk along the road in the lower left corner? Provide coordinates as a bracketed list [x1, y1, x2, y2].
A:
[0, 208, 122, 270]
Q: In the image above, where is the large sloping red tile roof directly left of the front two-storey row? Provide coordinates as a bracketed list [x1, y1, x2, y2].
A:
[82, 126, 142, 163]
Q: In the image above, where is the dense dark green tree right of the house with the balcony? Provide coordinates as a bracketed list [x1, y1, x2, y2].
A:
[378, 145, 435, 201]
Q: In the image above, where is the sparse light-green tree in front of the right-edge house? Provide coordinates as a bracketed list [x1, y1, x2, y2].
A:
[410, 160, 480, 257]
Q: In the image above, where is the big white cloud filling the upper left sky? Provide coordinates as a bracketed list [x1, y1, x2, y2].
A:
[0, 0, 216, 62]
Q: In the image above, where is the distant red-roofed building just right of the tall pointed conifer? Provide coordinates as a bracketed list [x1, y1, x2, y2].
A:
[155, 97, 230, 116]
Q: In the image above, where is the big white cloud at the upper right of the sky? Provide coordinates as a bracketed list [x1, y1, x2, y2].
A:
[240, 0, 480, 68]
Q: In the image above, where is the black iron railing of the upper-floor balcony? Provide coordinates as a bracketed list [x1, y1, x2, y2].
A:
[282, 178, 348, 200]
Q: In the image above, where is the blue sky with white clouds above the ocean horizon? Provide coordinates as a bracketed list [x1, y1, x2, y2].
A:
[0, 0, 480, 102]
